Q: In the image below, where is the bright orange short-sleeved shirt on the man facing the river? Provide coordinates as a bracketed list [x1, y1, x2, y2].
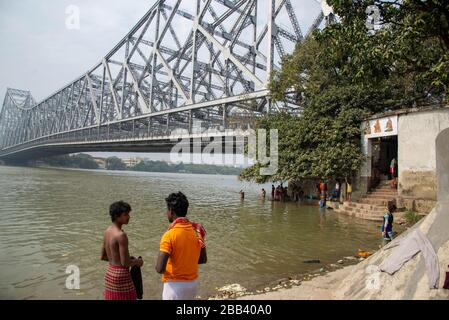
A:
[159, 223, 201, 282]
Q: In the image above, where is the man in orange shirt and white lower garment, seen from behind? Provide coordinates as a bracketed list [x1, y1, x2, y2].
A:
[156, 192, 207, 300]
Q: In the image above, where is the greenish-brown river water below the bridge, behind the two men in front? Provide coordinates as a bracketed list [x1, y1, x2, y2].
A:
[0, 166, 380, 299]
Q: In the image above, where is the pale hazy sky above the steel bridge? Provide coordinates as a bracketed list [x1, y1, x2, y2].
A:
[0, 0, 320, 162]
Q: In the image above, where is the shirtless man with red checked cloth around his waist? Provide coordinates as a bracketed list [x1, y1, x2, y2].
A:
[101, 201, 143, 300]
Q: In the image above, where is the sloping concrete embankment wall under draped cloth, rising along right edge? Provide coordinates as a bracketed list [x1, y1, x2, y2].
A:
[333, 124, 449, 301]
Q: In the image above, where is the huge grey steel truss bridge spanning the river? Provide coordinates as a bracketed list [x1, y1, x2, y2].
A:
[0, 0, 335, 162]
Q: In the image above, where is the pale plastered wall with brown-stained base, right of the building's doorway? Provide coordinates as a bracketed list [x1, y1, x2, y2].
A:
[398, 108, 449, 212]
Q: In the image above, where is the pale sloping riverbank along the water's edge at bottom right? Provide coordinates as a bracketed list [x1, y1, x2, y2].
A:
[231, 202, 449, 300]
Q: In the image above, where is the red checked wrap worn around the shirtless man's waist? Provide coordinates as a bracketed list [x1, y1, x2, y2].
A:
[104, 264, 137, 300]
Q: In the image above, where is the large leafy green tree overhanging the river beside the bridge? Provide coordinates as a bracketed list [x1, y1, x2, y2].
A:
[240, 0, 449, 183]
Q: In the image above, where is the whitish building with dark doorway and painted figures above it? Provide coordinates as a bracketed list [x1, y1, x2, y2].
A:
[357, 106, 449, 212]
